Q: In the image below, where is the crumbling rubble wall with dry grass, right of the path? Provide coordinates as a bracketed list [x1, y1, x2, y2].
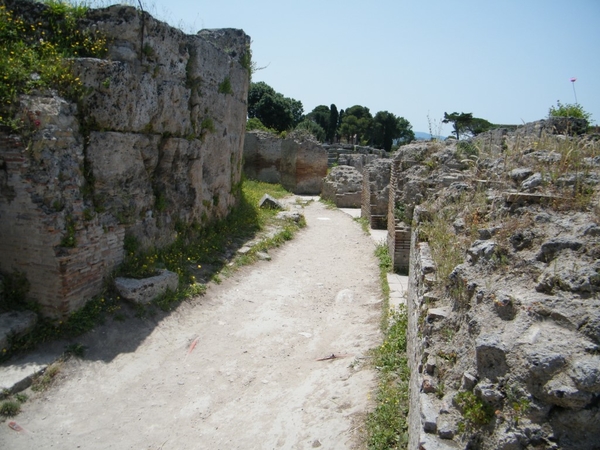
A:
[388, 122, 600, 449]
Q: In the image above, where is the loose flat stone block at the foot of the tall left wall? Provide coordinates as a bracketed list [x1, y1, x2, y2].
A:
[115, 270, 179, 304]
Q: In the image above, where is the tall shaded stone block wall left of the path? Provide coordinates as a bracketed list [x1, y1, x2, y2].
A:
[0, 1, 250, 316]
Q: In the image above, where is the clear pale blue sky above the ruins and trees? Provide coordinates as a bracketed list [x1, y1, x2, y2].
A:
[138, 0, 600, 134]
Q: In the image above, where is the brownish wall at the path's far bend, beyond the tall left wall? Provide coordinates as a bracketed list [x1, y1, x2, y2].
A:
[244, 131, 327, 195]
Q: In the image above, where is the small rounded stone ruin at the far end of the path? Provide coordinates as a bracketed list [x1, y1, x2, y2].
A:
[321, 166, 363, 208]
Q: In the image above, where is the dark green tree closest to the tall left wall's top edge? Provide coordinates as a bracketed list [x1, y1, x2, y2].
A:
[248, 81, 303, 132]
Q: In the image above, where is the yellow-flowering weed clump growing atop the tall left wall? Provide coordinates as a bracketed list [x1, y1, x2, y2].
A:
[0, 0, 107, 131]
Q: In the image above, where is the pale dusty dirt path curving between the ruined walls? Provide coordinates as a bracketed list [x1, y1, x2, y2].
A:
[0, 202, 381, 450]
